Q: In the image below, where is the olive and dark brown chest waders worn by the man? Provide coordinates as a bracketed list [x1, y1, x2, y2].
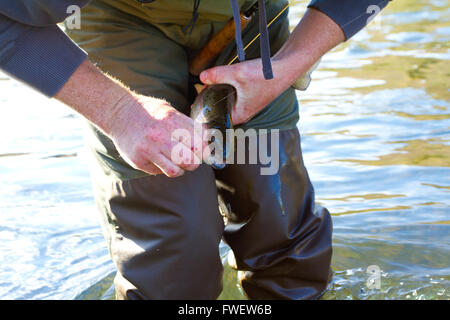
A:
[68, 0, 332, 299]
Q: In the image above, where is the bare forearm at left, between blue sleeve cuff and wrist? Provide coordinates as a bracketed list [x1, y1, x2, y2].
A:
[55, 60, 135, 134]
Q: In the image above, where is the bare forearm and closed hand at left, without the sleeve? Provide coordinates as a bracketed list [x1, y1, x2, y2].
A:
[56, 60, 207, 177]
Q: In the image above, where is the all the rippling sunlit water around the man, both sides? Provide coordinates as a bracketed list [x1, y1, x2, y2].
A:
[0, 0, 450, 299]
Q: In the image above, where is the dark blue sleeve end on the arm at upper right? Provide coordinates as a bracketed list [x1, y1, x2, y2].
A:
[308, 0, 391, 40]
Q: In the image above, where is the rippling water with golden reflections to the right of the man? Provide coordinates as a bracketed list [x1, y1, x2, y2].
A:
[299, 1, 450, 299]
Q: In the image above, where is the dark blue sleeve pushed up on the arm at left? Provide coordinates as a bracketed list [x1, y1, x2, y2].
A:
[0, 1, 87, 97]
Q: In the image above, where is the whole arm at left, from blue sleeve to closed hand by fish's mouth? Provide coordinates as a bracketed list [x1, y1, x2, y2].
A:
[0, 0, 202, 177]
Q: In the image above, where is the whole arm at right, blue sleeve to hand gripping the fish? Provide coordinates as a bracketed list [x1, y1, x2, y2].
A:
[200, 0, 388, 124]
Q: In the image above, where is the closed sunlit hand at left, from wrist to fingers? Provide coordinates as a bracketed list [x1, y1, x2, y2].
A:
[107, 95, 206, 178]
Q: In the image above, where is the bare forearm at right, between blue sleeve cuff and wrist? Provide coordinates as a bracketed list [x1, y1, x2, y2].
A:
[273, 9, 345, 85]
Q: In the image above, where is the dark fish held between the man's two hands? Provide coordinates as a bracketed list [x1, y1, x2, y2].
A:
[190, 84, 237, 169]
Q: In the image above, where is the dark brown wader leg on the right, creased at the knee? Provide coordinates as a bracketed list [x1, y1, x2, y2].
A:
[216, 129, 332, 299]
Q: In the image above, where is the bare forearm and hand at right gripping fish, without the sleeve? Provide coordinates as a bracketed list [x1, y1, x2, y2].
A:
[200, 9, 345, 124]
